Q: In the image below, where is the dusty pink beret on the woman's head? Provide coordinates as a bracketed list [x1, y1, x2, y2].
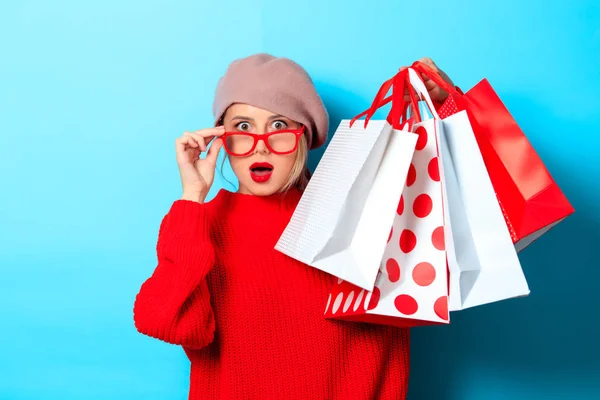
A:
[213, 53, 329, 149]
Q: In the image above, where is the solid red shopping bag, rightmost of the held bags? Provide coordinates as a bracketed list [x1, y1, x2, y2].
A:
[413, 62, 574, 251]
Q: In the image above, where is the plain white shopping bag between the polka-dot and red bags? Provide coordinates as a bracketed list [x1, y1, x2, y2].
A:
[409, 69, 529, 311]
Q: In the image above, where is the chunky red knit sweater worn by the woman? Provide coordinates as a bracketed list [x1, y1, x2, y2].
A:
[134, 190, 409, 400]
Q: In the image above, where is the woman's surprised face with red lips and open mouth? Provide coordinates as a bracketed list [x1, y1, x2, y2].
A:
[223, 104, 301, 196]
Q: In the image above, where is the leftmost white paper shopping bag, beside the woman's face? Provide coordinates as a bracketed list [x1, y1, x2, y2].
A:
[275, 120, 417, 290]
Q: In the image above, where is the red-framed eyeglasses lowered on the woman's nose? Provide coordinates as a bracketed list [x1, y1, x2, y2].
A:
[221, 125, 305, 157]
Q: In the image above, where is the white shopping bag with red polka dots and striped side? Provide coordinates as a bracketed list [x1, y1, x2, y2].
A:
[325, 70, 449, 327]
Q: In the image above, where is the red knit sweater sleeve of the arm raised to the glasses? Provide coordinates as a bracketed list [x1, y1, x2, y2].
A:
[133, 200, 215, 349]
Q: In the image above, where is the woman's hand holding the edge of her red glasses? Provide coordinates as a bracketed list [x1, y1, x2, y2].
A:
[175, 126, 225, 203]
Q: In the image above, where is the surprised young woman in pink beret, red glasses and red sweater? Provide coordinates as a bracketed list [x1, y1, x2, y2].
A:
[134, 54, 449, 400]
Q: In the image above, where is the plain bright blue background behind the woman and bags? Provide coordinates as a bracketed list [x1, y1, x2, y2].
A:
[0, 0, 600, 400]
